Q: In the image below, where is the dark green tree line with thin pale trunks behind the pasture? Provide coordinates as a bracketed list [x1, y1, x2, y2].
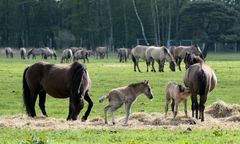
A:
[0, 0, 240, 49]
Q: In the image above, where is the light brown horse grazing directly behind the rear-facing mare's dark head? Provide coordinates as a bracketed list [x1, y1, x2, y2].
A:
[172, 45, 204, 71]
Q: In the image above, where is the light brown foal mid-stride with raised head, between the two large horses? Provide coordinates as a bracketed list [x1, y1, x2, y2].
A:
[99, 80, 153, 125]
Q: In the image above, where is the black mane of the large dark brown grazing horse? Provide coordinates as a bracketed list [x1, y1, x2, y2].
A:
[70, 62, 85, 94]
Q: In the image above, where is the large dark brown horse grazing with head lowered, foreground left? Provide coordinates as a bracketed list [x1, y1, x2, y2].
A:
[23, 62, 93, 121]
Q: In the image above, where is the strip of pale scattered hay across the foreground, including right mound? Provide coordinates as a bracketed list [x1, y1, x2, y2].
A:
[0, 102, 240, 130]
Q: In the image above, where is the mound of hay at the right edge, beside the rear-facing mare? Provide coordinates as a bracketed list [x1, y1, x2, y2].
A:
[206, 101, 240, 118]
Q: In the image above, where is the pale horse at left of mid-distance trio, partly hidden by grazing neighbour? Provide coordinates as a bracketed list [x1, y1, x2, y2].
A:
[131, 45, 150, 72]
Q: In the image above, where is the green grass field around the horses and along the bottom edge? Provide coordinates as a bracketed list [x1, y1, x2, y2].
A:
[0, 53, 240, 144]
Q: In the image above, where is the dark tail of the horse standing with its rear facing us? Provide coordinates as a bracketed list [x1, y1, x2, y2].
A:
[198, 69, 208, 95]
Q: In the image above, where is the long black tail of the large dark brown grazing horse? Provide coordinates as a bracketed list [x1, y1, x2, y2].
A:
[23, 67, 31, 115]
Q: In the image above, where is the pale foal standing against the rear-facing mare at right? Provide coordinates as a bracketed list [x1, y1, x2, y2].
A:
[165, 82, 190, 118]
